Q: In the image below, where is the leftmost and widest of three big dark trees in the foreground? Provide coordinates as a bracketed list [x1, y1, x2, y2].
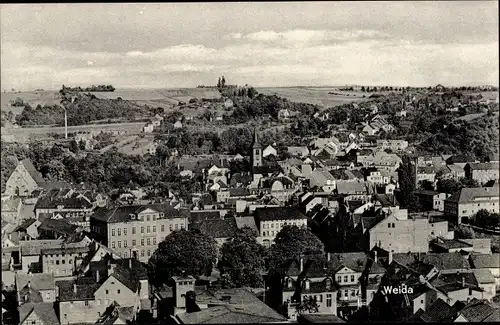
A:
[148, 229, 217, 285]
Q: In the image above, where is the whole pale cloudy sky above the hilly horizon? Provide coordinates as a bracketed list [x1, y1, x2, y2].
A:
[0, 1, 499, 90]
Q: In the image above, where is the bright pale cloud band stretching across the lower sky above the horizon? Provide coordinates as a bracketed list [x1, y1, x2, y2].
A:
[1, 29, 499, 89]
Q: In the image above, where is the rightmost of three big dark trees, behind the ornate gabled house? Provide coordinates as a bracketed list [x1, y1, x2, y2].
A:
[269, 225, 324, 275]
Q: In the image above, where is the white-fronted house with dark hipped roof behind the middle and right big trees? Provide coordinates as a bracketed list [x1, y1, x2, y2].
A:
[255, 207, 307, 246]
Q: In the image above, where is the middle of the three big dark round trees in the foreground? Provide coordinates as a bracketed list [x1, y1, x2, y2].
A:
[218, 227, 266, 288]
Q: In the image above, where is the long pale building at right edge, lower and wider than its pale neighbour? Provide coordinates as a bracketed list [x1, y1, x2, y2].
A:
[444, 186, 500, 224]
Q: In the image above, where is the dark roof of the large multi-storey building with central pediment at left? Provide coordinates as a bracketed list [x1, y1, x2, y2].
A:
[91, 204, 189, 223]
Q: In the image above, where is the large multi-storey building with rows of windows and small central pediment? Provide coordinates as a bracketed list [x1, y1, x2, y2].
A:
[90, 204, 189, 262]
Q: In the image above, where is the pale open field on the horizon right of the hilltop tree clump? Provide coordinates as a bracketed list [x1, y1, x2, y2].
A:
[257, 87, 370, 108]
